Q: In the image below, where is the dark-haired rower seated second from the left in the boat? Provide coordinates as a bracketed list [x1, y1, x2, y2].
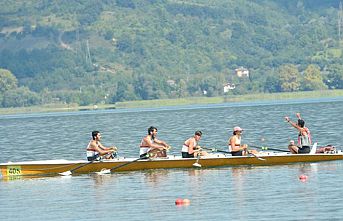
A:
[139, 126, 170, 158]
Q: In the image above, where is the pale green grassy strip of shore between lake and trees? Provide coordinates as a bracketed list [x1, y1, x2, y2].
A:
[0, 90, 343, 115]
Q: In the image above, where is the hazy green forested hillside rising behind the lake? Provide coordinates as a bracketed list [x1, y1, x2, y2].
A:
[0, 0, 343, 107]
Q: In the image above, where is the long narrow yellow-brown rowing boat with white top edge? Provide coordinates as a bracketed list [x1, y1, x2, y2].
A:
[0, 151, 343, 177]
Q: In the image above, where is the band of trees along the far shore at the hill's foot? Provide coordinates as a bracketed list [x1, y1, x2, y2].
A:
[0, 61, 343, 107]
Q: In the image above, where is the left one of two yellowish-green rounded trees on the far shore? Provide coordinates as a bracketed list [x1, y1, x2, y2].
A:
[279, 64, 301, 92]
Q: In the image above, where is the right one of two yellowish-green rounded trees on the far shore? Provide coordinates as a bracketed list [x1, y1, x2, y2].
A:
[302, 64, 327, 91]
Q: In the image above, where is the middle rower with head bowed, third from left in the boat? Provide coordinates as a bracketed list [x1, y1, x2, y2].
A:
[182, 130, 208, 158]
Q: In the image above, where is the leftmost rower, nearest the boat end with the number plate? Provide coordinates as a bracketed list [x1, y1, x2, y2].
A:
[87, 131, 117, 161]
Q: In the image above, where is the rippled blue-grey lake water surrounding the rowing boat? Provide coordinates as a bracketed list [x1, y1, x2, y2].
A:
[0, 98, 343, 221]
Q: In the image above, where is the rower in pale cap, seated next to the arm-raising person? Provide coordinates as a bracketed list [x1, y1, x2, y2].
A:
[228, 126, 258, 156]
